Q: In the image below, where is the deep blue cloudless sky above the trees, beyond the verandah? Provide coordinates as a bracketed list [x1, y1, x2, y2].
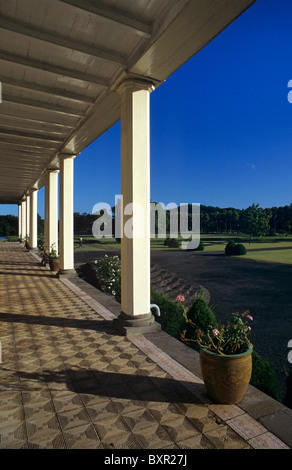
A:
[0, 0, 292, 216]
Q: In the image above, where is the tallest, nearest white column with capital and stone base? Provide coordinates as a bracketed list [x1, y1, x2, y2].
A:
[114, 80, 160, 334]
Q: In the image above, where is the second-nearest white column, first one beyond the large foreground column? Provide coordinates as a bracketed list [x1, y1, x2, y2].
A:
[59, 154, 76, 277]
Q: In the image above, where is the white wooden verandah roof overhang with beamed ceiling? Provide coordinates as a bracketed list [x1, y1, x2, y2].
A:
[0, 0, 255, 204]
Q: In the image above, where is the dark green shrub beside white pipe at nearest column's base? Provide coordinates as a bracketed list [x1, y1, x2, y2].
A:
[151, 288, 184, 339]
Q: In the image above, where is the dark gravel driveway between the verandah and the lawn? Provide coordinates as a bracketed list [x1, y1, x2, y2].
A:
[75, 251, 292, 398]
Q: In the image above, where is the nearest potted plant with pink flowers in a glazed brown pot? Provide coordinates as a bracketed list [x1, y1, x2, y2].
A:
[177, 296, 253, 405]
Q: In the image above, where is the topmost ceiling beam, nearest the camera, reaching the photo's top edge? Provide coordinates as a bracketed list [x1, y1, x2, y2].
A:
[61, 0, 152, 38]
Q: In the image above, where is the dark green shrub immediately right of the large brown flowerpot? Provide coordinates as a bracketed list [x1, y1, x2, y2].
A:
[250, 351, 279, 400]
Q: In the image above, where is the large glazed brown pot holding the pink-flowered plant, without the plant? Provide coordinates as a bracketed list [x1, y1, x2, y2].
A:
[200, 347, 252, 405]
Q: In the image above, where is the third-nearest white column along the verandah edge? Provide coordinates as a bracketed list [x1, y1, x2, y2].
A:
[45, 170, 58, 252]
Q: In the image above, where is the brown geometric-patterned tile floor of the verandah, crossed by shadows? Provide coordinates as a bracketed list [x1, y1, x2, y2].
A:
[0, 243, 287, 449]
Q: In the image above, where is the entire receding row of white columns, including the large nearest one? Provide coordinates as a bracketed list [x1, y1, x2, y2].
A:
[17, 79, 160, 334]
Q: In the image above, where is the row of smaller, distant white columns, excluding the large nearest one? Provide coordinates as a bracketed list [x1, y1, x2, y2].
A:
[18, 155, 75, 275]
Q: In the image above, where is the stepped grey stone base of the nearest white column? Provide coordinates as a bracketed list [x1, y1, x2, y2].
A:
[113, 312, 161, 336]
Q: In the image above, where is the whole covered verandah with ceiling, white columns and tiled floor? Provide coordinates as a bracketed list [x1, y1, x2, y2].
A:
[0, 0, 292, 449]
